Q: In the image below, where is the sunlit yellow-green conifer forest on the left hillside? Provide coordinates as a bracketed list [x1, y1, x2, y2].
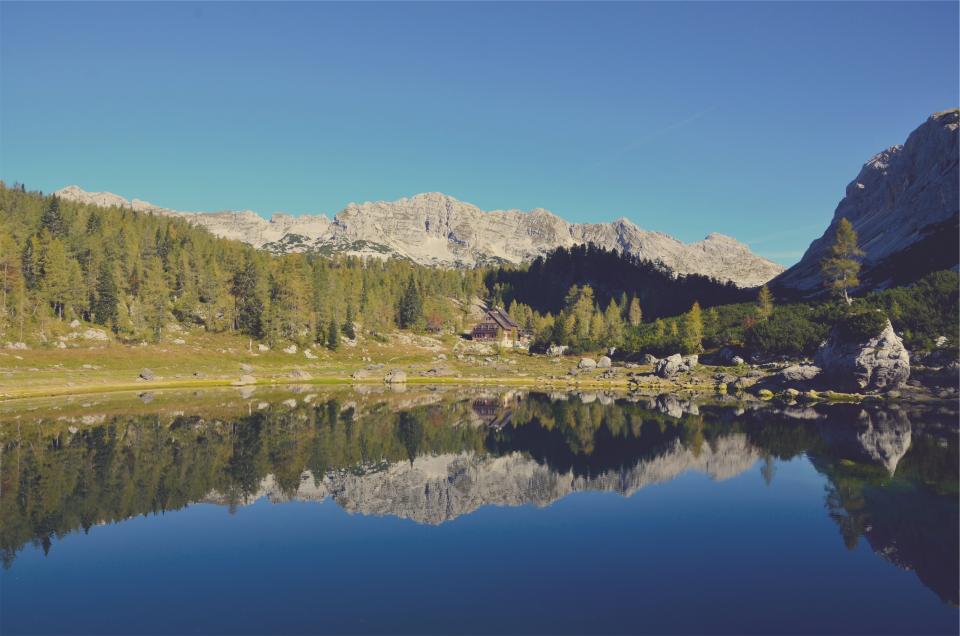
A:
[0, 182, 483, 347]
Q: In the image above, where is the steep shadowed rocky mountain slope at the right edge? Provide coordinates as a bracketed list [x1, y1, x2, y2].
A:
[771, 109, 960, 296]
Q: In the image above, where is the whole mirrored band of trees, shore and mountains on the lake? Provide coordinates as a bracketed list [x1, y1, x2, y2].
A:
[0, 392, 958, 604]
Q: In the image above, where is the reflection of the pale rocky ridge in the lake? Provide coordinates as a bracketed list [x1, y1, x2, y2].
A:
[208, 434, 760, 524]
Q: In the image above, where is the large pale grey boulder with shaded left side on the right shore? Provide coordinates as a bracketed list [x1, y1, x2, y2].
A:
[815, 320, 910, 391]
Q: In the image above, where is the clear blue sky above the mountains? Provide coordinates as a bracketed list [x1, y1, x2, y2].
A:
[0, 2, 960, 264]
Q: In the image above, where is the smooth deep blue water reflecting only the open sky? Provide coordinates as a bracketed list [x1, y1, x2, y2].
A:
[0, 390, 958, 635]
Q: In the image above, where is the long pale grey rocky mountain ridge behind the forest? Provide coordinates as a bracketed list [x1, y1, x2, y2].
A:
[57, 186, 783, 287]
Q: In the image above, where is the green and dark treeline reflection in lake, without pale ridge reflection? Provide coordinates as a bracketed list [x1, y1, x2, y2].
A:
[0, 394, 958, 602]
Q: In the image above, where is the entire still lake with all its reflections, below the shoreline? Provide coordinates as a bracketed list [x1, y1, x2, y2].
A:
[0, 388, 958, 635]
